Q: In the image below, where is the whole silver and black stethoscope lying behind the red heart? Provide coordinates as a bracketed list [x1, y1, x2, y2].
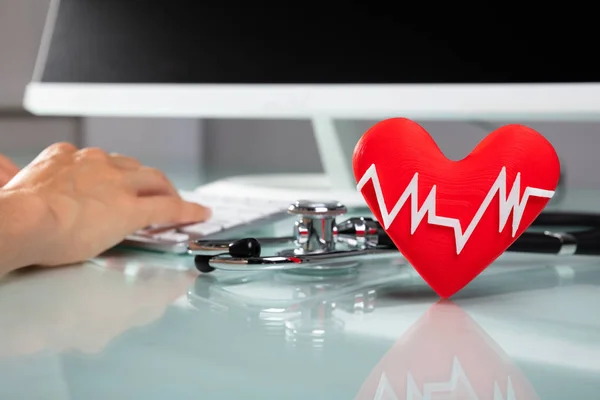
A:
[188, 200, 600, 273]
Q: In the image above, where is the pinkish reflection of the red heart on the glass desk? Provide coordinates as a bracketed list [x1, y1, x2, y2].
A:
[356, 300, 538, 400]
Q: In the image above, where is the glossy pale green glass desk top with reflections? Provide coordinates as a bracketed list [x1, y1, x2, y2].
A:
[0, 190, 600, 400]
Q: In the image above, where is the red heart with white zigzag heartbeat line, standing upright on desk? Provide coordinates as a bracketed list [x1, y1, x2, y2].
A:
[352, 118, 560, 297]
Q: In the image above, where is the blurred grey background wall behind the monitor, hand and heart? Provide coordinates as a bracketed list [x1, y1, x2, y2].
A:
[0, 0, 600, 188]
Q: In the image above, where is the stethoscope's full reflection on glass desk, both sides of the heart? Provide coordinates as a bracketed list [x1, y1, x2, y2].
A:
[188, 255, 600, 348]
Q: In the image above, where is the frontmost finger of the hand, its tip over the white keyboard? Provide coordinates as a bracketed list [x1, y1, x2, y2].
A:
[134, 196, 211, 229]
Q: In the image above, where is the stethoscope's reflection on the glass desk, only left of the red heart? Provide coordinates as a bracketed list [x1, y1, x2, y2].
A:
[188, 262, 423, 349]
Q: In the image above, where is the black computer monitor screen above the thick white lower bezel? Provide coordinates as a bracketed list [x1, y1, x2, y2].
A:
[42, 0, 600, 84]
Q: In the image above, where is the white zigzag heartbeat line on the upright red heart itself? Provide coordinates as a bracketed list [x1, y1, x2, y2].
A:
[357, 164, 554, 254]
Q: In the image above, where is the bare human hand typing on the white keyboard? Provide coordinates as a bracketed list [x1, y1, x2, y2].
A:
[3, 143, 210, 266]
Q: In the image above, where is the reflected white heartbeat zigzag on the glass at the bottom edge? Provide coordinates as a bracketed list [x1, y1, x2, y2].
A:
[374, 357, 516, 400]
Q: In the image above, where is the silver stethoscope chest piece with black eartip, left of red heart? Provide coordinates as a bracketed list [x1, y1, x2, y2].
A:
[189, 200, 399, 273]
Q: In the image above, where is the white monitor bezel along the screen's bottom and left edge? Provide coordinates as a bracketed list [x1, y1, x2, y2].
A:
[23, 0, 600, 121]
